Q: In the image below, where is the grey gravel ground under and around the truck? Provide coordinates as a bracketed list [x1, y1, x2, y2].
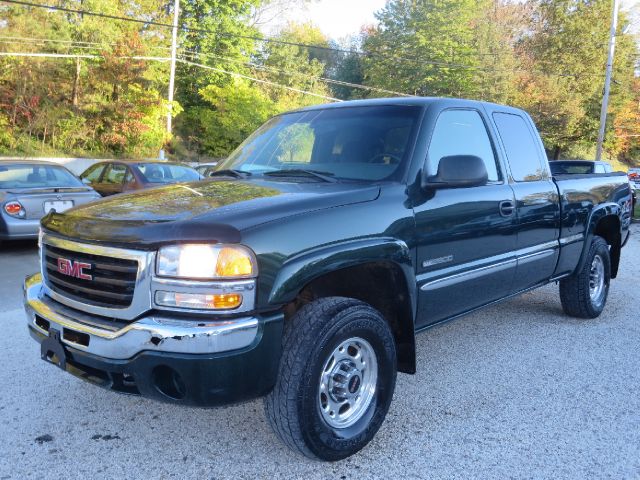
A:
[0, 230, 640, 480]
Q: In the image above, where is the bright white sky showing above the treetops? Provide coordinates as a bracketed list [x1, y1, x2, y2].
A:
[264, 0, 640, 39]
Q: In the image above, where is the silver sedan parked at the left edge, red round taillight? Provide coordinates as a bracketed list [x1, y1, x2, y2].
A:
[0, 160, 101, 242]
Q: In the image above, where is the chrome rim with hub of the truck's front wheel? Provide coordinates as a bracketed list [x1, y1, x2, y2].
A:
[318, 337, 378, 428]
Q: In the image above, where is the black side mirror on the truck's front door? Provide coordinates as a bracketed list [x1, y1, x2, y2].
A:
[422, 155, 488, 189]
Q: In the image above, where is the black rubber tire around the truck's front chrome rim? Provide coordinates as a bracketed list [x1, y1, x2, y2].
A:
[264, 297, 396, 461]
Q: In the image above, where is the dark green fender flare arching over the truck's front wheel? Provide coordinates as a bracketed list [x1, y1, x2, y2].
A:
[269, 238, 417, 318]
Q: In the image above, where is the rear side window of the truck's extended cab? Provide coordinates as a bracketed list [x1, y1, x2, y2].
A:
[493, 113, 545, 182]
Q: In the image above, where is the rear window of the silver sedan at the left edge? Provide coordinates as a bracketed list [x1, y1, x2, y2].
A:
[0, 164, 84, 189]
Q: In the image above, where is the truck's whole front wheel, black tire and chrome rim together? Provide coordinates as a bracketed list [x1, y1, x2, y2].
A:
[265, 297, 396, 461]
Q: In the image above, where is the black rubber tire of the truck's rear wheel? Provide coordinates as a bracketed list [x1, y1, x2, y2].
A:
[560, 236, 611, 318]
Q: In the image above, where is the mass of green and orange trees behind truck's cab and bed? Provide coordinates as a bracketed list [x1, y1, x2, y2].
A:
[358, 0, 640, 163]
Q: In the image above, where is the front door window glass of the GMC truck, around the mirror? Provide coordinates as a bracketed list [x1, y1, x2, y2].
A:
[427, 110, 500, 182]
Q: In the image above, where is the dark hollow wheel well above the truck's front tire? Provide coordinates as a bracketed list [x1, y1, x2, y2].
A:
[284, 262, 416, 373]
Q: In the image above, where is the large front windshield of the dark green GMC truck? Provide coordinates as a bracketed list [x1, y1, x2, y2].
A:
[216, 105, 421, 181]
